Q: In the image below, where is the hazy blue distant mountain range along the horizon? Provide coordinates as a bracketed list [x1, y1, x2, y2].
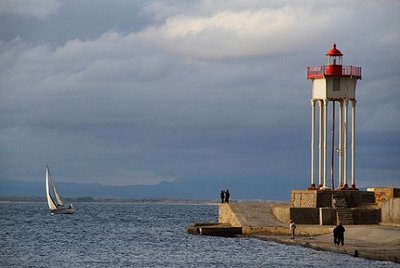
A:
[0, 180, 290, 201]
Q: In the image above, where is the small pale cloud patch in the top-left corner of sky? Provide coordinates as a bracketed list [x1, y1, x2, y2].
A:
[0, 0, 61, 19]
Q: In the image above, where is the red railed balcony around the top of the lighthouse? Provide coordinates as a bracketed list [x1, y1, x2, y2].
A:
[307, 65, 361, 79]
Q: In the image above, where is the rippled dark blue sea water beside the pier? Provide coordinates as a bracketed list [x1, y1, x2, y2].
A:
[0, 203, 400, 268]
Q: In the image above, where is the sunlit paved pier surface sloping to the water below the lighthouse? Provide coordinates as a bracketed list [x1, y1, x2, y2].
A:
[219, 202, 400, 263]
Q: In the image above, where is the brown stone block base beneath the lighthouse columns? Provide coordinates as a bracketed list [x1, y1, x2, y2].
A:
[289, 190, 381, 225]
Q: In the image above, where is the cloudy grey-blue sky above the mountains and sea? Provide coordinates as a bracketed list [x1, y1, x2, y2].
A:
[0, 0, 400, 196]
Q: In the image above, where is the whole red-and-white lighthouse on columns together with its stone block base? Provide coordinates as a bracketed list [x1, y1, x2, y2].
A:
[290, 44, 381, 225]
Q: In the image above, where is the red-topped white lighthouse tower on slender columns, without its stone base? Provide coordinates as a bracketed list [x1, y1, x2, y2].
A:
[307, 44, 361, 190]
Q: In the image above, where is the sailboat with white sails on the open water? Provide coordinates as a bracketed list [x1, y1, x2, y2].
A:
[46, 166, 75, 214]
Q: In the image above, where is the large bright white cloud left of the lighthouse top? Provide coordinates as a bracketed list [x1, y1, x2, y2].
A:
[139, 6, 332, 58]
